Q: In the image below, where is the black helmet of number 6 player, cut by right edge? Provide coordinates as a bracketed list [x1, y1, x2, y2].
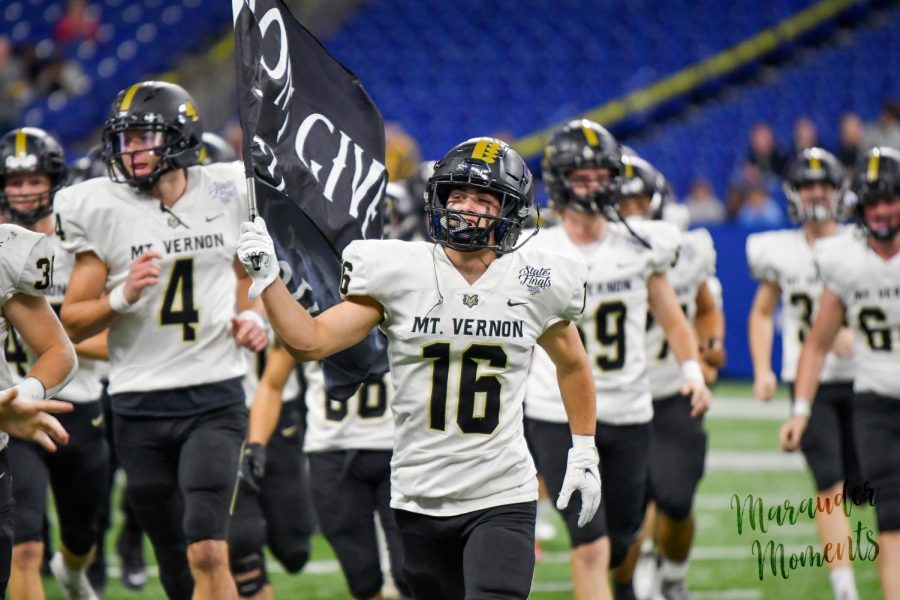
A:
[853, 147, 900, 241]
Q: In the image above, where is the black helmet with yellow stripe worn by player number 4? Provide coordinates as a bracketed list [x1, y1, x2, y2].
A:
[103, 81, 203, 192]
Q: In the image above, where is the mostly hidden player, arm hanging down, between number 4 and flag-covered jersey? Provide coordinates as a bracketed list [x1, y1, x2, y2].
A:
[228, 343, 315, 600]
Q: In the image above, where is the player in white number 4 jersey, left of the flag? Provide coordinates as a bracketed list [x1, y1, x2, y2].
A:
[54, 81, 266, 600]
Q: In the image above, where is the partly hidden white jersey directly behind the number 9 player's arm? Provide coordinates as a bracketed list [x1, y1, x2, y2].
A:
[647, 229, 716, 399]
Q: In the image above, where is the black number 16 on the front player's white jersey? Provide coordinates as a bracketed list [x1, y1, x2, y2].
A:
[422, 342, 507, 435]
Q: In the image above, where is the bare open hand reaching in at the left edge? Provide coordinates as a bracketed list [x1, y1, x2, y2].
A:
[0, 387, 74, 452]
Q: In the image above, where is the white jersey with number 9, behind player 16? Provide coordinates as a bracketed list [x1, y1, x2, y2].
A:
[525, 220, 681, 425]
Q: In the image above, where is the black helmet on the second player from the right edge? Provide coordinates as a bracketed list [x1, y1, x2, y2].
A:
[782, 148, 847, 223]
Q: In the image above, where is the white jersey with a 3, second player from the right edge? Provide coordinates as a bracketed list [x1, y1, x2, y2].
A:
[747, 229, 856, 383]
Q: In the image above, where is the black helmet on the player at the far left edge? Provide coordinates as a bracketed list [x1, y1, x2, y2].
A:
[0, 127, 69, 226]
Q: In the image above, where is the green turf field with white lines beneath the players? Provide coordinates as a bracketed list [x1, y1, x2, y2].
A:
[46, 383, 881, 600]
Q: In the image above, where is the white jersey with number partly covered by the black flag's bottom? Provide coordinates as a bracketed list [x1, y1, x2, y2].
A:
[303, 361, 394, 452]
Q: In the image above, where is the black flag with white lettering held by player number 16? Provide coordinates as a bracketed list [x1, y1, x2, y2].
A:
[232, 0, 387, 399]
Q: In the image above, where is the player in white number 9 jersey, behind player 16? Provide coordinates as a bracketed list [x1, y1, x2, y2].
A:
[525, 120, 710, 598]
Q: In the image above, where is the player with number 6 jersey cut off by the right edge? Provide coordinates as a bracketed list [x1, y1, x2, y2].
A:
[781, 148, 900, 599]
